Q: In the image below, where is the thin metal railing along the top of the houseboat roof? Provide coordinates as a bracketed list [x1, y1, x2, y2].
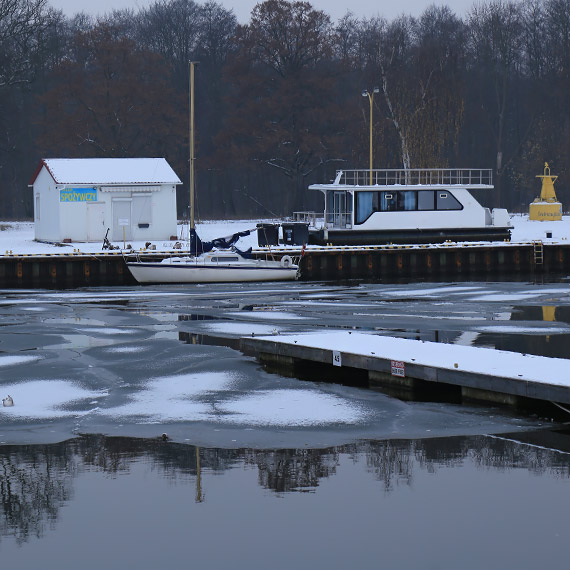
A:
[335, 168, 493, 188]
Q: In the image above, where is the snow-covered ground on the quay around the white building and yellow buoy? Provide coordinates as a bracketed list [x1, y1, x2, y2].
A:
[0, 214, 570, 255]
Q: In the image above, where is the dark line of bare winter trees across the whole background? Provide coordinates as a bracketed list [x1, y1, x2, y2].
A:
[0, 0, 570, 219]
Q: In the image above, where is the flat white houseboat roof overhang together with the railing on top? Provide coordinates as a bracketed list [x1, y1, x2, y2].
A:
[309, 168, 494, 191]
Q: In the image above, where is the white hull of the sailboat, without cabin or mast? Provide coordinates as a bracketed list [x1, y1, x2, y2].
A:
[127, 262, 297, 283]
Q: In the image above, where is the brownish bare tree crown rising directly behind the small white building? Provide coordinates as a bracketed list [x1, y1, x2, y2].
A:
[36, 25, 187, 161]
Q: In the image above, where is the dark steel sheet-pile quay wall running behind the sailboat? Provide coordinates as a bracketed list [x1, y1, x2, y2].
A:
[0, 237, 570, 289]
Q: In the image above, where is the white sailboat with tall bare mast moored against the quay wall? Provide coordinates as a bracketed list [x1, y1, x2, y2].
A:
[126, 62, 299, 283]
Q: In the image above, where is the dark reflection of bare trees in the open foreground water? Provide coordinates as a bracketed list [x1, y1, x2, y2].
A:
[0, 430, 570, 543]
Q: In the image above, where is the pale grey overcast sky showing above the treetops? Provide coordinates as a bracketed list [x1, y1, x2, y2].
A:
[48, 0, 474, 23]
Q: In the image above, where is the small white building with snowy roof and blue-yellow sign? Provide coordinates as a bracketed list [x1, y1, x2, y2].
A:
[30, 158, 181, 242]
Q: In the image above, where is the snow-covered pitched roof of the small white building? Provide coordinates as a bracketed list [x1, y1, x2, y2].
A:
[31, 158, 181, 185]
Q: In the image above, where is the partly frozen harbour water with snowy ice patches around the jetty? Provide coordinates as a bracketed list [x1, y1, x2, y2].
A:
[0, 282, 570, 569]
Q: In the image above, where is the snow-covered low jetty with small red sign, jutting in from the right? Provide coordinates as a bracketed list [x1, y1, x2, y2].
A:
[242, 331, 570, 408]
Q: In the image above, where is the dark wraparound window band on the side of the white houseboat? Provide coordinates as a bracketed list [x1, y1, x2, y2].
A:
[354, 190, 463, 224]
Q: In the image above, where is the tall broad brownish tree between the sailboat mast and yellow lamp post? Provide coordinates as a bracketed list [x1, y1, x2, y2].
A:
[220, 0, 340, 207]
